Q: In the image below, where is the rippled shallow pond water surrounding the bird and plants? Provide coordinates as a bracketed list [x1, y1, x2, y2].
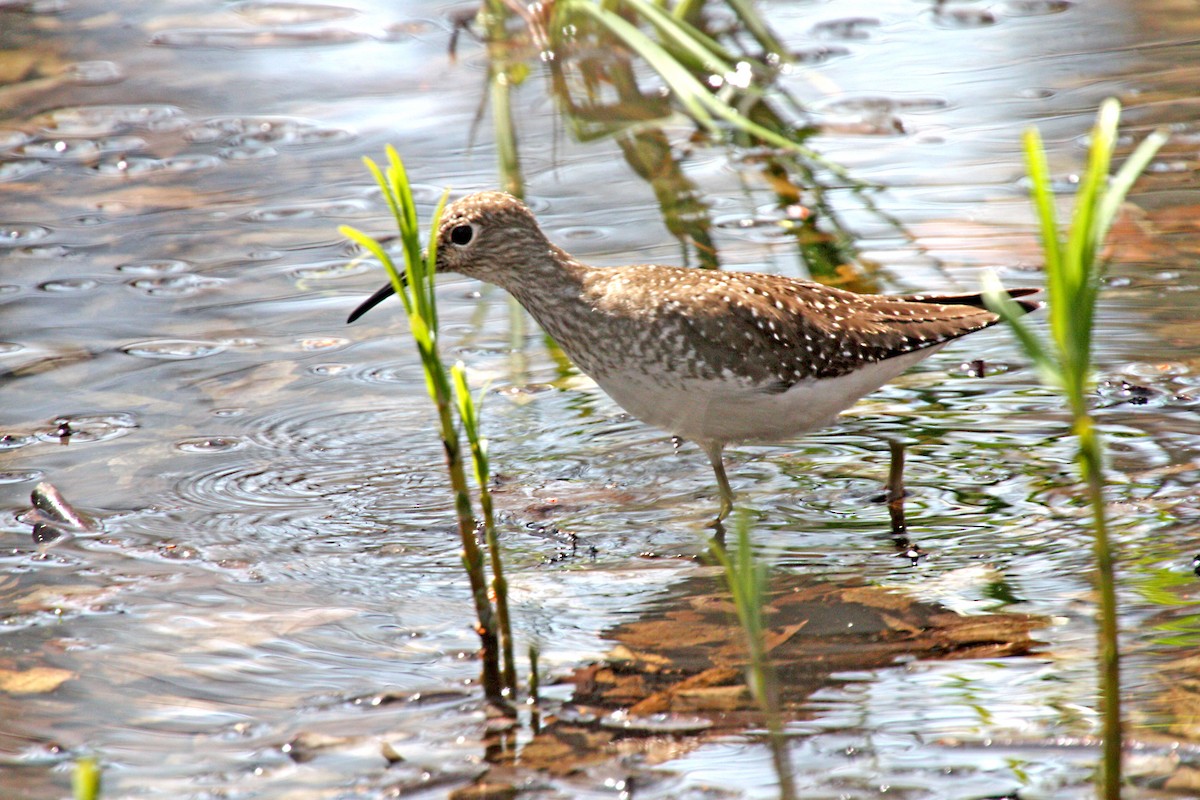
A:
[0, 0, 1200, 799]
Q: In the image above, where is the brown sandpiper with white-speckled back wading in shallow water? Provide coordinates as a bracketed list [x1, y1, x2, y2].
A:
[349, 192, 1039, 519]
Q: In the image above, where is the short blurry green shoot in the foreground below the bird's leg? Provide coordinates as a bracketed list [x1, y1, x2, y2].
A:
[712, 515, 796, 800]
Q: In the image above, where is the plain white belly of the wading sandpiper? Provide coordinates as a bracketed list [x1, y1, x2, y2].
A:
[596, 345, 943, 443]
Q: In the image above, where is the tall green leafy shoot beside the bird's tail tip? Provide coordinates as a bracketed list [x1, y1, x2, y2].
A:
[988, 98, 1166, 800]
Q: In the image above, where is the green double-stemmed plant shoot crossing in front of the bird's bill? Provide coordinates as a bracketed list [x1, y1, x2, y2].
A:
[340, 148, 516, 700]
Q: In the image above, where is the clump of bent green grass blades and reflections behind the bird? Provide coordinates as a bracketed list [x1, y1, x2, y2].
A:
[474, 0, 882, 280]
